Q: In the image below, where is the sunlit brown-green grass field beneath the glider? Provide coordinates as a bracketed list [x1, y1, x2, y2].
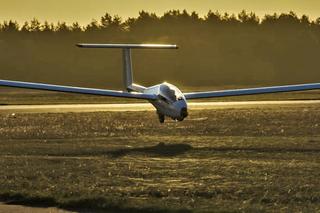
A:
[0, 105, 320, 212]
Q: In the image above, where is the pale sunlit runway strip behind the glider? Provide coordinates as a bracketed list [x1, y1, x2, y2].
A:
[0, 100, 320, 113]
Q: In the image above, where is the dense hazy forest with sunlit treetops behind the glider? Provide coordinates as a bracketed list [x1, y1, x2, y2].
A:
[0, 10, 320, 88]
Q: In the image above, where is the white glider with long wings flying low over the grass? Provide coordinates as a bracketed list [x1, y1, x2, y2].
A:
[0, 44, 320, 123]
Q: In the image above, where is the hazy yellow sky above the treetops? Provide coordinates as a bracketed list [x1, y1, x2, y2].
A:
[0, 0, 320, 25]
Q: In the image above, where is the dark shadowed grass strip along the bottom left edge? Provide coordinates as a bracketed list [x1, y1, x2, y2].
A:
[0, 193, 192, 213]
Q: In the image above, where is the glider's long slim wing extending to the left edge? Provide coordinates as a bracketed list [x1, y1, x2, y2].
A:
[0, 80, 156, 100]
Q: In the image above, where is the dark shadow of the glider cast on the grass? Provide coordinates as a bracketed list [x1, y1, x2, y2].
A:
[104, 143, 320, 157]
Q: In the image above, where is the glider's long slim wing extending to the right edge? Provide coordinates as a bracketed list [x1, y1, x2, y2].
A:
[184, 83, 320, 99]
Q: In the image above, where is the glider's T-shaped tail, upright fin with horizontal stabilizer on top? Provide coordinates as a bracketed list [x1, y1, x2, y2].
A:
[77, 44, 178, 92]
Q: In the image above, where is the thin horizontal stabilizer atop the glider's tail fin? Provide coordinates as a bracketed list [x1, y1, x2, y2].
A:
[77, 44, 178, 49]
